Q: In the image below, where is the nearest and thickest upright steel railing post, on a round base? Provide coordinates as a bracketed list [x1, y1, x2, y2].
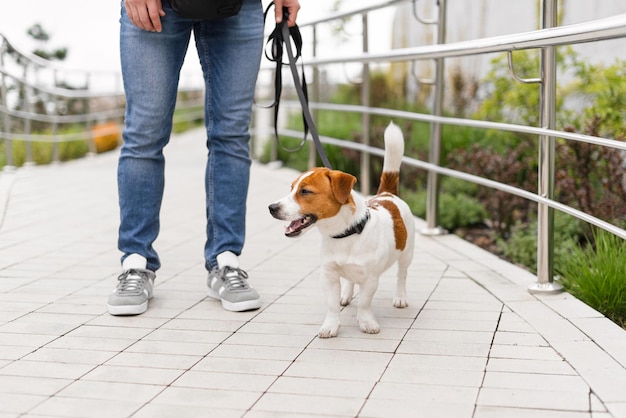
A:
[528, 0, 563, 293]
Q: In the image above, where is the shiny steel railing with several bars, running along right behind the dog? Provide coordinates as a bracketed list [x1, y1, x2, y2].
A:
[256, 0, 626, 293]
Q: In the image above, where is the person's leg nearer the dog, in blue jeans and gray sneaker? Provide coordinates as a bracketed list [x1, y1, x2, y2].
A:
[194, 0, 263, 310]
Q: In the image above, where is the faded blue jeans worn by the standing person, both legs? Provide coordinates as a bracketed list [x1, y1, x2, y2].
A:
[118, 0, 263, 271]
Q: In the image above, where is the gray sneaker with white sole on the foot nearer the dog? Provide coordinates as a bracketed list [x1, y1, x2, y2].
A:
[207, 266, 261, 312]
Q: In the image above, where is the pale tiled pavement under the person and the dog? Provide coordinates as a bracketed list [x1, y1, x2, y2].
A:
[0, 131, 626, 418]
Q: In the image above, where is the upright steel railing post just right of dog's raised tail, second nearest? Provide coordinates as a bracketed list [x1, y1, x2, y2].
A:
[420, 0, 446, 235]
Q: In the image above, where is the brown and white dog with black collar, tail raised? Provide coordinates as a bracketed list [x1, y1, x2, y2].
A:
[269, 122, 415, 338]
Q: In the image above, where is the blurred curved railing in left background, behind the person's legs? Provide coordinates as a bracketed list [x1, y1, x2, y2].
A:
[0, 34, 204, 171]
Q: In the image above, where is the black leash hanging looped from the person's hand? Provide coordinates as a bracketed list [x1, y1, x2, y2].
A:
[264, 2, 332, 168]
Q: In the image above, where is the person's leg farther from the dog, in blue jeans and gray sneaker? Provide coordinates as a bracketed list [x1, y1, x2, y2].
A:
[108, 7, 193, 315]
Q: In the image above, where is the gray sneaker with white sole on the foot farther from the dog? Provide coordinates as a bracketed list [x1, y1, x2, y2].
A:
[107, 269, 156, 315]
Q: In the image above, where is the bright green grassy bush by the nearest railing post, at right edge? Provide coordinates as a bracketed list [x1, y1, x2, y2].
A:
[555, 230, 626, 327]
